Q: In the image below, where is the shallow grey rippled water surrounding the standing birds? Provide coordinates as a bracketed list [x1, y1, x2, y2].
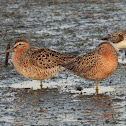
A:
[0, 0, 126, 126]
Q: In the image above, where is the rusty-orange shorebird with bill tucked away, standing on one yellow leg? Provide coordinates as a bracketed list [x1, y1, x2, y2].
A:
[62, 42, 118, 92]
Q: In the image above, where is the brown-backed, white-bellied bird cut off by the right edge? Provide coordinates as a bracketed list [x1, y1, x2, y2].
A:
[101, 30, 126, 51]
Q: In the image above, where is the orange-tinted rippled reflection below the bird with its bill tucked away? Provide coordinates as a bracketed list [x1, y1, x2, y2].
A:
[77, 94, 119, 124]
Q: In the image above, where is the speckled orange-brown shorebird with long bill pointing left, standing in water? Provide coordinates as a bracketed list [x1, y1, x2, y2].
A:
[0, 40, 74, 87]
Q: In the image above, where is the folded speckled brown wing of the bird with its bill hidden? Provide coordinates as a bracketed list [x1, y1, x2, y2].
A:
[62, 51, 98, 76]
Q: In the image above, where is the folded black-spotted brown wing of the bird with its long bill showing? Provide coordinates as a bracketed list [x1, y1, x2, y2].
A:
[25, 48, 74, 69]
